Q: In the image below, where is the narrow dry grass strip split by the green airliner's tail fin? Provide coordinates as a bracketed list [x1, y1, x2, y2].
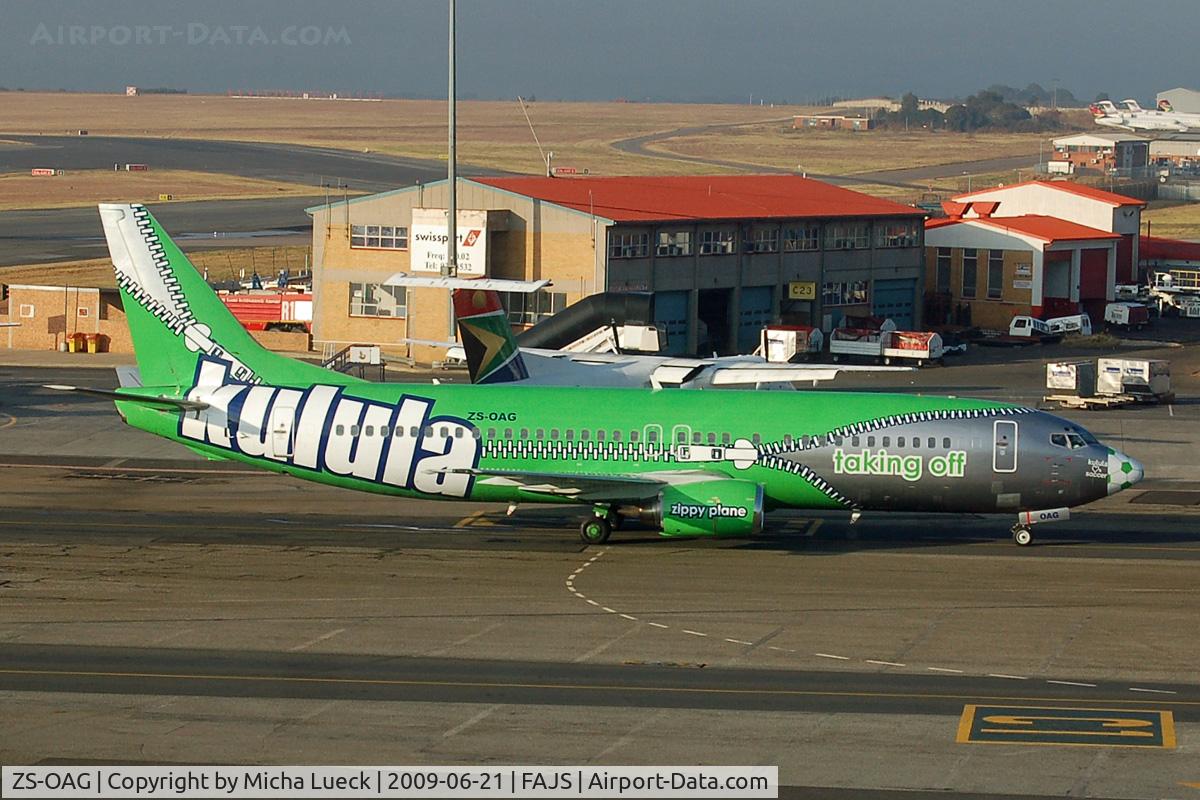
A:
[0, 246, 308, 288]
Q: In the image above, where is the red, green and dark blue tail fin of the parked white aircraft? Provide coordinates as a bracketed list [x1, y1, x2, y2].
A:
[454, 288, 529, 384]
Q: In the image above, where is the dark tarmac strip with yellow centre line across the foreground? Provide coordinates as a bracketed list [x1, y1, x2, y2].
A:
[0, 644, 1200, 722]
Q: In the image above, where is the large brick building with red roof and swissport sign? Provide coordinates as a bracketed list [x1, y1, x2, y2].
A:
[308, 175, 924, 362]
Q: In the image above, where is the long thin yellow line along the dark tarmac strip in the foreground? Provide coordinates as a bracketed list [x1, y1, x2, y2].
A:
[0, 669, 1200, 712]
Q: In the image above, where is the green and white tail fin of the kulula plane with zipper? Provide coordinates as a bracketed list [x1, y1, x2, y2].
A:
[100, 203, 347, 386]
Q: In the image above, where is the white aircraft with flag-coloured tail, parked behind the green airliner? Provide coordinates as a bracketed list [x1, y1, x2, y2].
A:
[427, 276, 914, 390]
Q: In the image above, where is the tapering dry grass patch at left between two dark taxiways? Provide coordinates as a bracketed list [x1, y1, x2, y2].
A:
[0, 169, 324, 211]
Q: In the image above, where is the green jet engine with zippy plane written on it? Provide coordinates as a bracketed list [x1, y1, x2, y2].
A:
[638, 479, 763, 536]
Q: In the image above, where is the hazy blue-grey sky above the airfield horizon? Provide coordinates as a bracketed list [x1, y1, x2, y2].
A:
[0, 0, 1200, 104]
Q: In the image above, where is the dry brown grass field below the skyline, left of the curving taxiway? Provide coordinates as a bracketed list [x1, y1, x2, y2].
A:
[0, 92, 825, 174]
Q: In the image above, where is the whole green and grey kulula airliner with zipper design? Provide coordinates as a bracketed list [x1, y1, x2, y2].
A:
[55, 204, 1142, 545]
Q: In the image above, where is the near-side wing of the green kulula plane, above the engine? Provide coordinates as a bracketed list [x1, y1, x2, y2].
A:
[436, 468, 722, 501]
